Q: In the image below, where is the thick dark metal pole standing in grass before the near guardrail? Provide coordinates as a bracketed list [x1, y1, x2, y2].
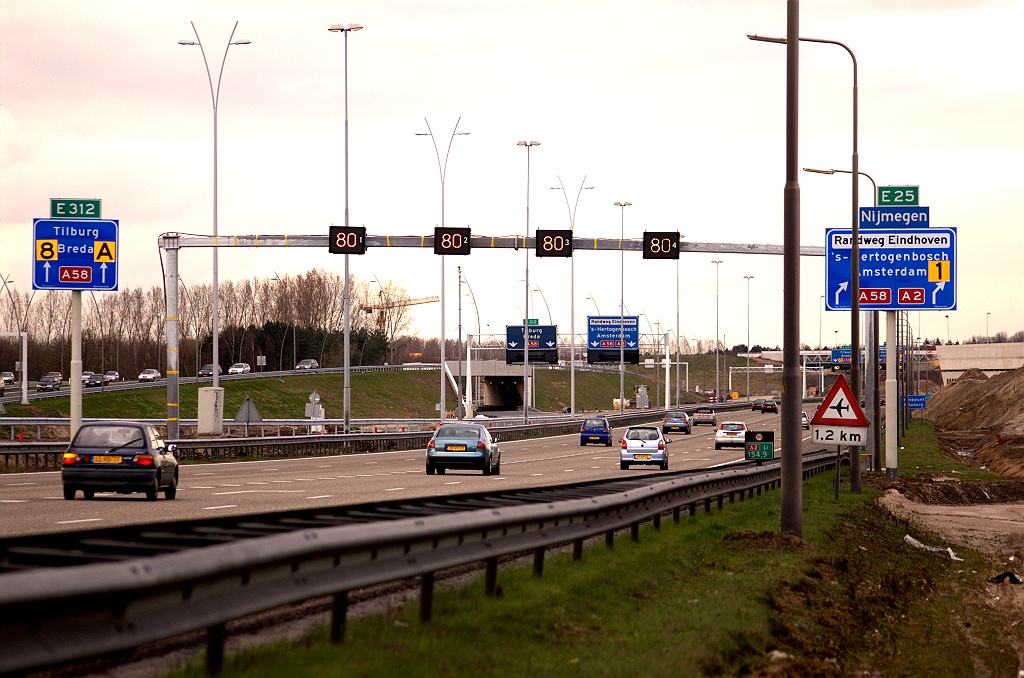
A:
[781, 0, 804, 537]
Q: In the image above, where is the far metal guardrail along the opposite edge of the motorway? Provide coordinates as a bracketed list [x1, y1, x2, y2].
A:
[0, 404, 746, 470]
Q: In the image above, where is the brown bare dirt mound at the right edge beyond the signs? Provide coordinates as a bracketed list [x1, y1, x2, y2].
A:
[924, 368, 1024, 477]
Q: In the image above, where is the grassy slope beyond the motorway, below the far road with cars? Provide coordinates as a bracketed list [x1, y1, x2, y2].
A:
[5, 370, 679, 426]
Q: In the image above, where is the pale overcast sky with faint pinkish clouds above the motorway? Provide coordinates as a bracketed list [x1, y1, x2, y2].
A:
[0, 0, 1024, 345]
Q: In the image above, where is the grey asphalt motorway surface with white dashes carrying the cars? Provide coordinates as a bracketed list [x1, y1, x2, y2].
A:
[0, 410, 817, 537]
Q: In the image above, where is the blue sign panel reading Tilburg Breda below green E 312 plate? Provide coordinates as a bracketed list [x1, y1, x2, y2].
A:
[32, 219, 118, 292]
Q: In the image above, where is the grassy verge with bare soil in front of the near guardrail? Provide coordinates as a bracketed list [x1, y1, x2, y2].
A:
[167, 423, 1022, 678]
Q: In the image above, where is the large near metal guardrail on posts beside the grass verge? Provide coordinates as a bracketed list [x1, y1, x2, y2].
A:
[0, 452, 837, 674]
